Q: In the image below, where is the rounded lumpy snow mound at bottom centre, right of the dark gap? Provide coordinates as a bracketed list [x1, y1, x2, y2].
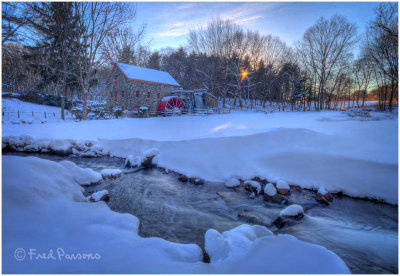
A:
[205, 224, 350, 274]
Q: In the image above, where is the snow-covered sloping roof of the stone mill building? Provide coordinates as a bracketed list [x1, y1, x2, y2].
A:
[115, 62, 180, 86]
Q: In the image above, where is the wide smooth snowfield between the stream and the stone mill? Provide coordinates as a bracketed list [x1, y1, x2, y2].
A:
[3, 111, 398, 204]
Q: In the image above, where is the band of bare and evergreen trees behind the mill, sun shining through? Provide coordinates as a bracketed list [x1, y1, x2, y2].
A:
[2, 2, 398, 119]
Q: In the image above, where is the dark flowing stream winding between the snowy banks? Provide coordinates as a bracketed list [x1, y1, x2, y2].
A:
[5, 154, 398, 274]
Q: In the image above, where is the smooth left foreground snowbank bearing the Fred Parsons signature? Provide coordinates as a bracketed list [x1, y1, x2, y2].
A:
[3, 156, 202, 274]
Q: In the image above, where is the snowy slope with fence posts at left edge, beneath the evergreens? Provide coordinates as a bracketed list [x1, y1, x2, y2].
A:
[1, 99, 74, 124]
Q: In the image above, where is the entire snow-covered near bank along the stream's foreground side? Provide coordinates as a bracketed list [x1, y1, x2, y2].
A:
[2, 156, 350, 274]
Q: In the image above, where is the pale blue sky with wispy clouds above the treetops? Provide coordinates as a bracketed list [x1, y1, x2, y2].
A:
[136, 2, 379, 49]
